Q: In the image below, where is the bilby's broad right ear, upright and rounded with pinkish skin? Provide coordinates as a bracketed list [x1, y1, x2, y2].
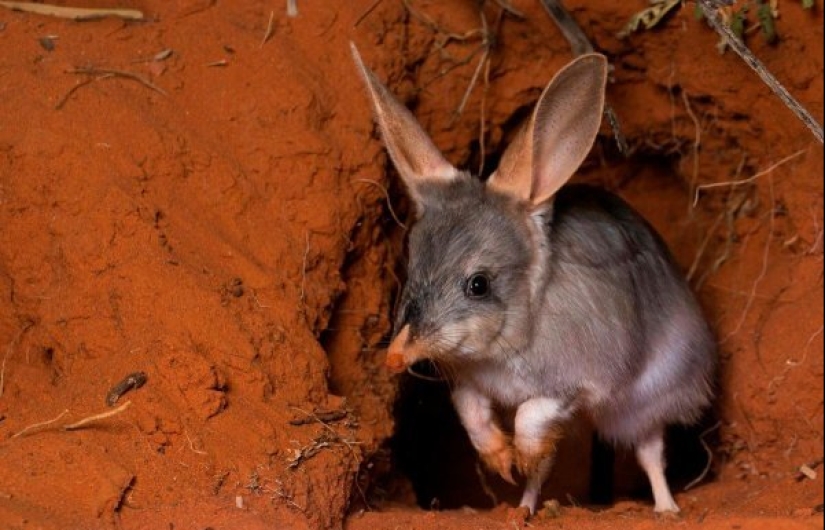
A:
[487, 53, 607, 205]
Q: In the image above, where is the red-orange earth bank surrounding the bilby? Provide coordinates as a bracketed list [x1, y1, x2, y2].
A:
[0, 0, 823, 529]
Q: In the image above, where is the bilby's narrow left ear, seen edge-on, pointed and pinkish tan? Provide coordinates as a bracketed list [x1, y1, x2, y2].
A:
[350, 43, 460, 211]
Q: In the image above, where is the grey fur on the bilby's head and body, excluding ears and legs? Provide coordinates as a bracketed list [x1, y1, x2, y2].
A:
[396, 182, 715, 446]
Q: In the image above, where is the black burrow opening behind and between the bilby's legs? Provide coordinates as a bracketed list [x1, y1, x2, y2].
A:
[390, 363, 716, 509]
